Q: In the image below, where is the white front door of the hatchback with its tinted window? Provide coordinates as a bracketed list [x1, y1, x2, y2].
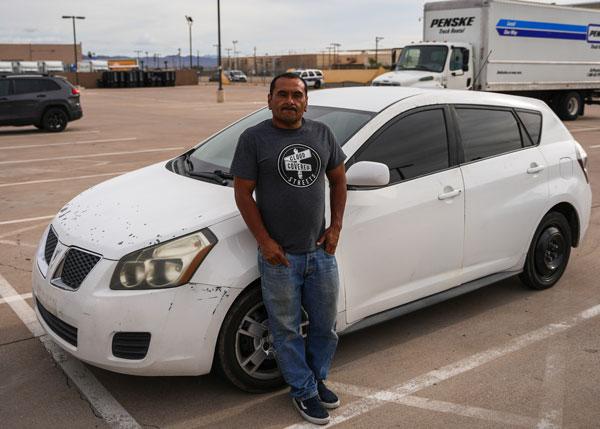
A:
[339, 106, 464, 323]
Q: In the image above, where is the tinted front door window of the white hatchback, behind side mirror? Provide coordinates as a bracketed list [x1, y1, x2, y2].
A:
[357, 109, 450, 183]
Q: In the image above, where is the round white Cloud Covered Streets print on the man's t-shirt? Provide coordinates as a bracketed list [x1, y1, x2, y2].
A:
[277, 144, 321, 188]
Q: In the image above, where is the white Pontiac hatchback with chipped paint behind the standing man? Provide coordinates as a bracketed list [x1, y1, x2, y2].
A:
[33, 87, 591, 391]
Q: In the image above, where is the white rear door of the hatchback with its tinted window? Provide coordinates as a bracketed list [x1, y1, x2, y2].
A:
[454, 106, 549, 282]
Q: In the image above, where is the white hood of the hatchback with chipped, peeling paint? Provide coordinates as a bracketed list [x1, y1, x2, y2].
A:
[52, 162, 239, 260]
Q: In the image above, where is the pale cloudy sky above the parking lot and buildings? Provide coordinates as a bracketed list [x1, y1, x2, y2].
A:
[0, 0, 600, 56]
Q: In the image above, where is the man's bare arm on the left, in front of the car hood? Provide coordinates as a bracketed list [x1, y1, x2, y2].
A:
[233, 176, 290, 267]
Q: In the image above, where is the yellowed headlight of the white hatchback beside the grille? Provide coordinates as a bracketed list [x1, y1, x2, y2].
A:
[110, 228, 217, 290]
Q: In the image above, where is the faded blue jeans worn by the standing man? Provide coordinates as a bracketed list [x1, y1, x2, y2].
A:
[258, 248, 339, 400]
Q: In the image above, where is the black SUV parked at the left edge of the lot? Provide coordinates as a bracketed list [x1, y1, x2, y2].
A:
[0, 75, 83, 132]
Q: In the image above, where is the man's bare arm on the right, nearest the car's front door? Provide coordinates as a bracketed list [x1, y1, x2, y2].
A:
[317, 163, 346, 255]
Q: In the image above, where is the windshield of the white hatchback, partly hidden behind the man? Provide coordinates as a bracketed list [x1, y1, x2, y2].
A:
[190, 106, 375, 171]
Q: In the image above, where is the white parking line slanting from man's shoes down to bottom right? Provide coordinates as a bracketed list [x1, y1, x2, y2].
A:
[328, 382, 537, 428]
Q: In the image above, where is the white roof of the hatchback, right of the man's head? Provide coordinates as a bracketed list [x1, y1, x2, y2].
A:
[308, 86, 545, 112]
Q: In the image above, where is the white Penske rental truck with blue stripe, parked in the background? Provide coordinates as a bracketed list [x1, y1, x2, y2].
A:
[372, 0, 600, 120]
